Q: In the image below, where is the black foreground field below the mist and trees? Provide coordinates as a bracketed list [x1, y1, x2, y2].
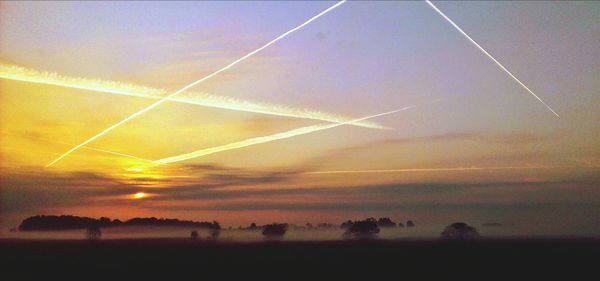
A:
[0, 239, 600, 280]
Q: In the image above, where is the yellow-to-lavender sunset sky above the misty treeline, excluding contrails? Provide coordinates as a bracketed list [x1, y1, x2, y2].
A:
[0, 1, 600, 235]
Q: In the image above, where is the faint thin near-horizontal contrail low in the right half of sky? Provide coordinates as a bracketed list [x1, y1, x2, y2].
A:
[305, 166, 565, 175]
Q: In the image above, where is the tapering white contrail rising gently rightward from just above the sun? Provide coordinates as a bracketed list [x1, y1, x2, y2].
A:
[154, 106, 413, 164]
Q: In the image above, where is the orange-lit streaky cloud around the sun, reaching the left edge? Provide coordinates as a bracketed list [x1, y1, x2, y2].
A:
[0, 162, 302, 213]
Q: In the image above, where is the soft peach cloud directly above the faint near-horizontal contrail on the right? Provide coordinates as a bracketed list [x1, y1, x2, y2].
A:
[306, 131, 575, 170]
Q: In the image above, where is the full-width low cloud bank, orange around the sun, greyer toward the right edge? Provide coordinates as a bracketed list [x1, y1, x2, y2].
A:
[0, 155, 600, 213]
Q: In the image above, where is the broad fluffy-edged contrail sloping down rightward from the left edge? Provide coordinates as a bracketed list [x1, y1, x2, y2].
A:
[0, 64, 389, 129]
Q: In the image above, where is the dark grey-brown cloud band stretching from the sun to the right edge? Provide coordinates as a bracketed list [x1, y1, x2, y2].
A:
[138, 176, 600, 211]
